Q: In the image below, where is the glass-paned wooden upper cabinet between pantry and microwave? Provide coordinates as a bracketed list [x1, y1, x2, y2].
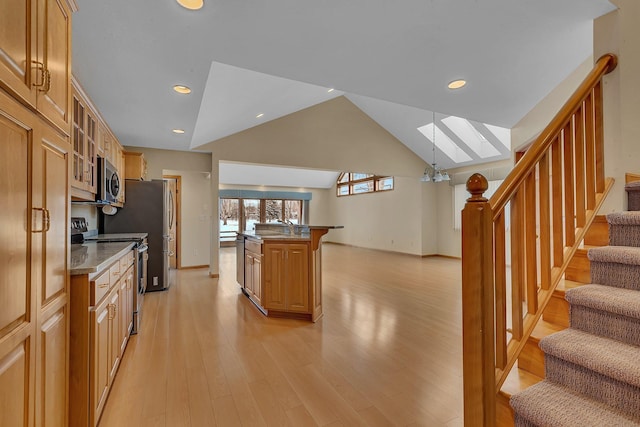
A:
[71, 80, 98, 200]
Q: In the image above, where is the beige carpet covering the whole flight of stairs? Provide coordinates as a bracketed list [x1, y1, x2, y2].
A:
[511, 211, 640, 427]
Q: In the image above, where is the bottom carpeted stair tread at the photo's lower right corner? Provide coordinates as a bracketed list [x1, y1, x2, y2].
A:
[510, 381, 640, 427]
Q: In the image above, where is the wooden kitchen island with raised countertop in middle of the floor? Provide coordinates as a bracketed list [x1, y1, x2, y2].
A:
[237, 224, 343, 322]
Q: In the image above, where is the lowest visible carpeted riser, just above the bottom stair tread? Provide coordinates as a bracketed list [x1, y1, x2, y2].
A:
[545, 354, 640, 417]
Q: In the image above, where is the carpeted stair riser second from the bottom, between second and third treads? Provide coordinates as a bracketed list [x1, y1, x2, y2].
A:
[570, 305, 640, 346]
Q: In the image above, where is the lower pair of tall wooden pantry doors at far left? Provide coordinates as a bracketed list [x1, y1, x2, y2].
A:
[0, 83, 70, 426]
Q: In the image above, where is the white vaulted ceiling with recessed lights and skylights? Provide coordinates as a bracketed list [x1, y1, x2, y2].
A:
[73, 0, 614, 182]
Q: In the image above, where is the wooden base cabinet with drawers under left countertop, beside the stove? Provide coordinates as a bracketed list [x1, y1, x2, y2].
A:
[69, 252, 135, 427]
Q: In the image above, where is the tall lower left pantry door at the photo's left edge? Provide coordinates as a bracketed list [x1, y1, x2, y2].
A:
[0, 90, 38, 426]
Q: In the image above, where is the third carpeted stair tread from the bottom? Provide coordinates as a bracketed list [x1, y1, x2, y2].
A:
[565, 284, 640, 319]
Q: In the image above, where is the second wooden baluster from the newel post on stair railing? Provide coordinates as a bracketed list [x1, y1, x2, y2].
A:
[510, 190, 525, 340]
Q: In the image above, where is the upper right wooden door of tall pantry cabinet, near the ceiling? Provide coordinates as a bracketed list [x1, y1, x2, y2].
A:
[37, 0, 71, 133]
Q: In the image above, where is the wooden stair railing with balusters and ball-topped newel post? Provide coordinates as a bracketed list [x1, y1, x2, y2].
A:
[462, 54, 617, 426]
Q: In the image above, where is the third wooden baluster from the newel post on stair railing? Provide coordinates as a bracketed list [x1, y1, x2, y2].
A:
[516, 168, 538, 314]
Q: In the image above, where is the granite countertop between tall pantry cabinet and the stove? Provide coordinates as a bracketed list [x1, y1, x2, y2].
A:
[69, 242, 135, 276]
